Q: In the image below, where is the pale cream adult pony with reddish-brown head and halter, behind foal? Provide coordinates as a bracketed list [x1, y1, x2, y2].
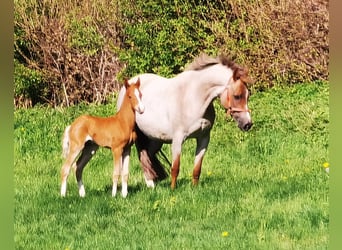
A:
[117, 54, 252, 189]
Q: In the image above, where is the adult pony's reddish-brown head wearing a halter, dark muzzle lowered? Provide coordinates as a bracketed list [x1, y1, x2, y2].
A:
[220, 64, 253, 131]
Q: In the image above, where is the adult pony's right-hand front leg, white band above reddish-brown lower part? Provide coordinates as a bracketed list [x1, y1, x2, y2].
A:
[192, 133, 210, 185]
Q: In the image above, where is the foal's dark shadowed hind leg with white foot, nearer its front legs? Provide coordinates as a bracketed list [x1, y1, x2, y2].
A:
[76, 141, 99, 197]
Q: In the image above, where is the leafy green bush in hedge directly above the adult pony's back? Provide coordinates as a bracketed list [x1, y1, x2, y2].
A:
[120, 0, 217, 76]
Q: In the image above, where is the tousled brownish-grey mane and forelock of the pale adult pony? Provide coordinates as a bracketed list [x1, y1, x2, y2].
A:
[185, 54, 252, 83]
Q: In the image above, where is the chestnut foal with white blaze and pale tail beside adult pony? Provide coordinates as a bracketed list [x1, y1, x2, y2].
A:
[61, 79, 145, 197]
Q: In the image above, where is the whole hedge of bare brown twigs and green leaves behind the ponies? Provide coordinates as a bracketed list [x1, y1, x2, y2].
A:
[14, 0, 329, 107]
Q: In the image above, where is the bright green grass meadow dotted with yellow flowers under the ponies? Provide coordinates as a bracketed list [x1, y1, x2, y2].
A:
[14, 83, 329, 249]
